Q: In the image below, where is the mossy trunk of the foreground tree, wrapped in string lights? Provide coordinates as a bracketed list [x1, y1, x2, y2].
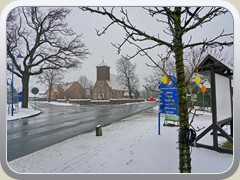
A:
[173, 7, 191, 173]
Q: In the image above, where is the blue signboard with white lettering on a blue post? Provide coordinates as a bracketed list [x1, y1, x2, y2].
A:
[158, 76, 179, 135]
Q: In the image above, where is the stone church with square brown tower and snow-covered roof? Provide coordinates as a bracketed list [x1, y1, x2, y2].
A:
[92, 61, 125, 100]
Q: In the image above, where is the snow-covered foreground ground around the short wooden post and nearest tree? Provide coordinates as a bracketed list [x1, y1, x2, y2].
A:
[9, 107, 233, 173]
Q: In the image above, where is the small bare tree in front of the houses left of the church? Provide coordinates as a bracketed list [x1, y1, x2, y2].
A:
[37, 69, 64, 102]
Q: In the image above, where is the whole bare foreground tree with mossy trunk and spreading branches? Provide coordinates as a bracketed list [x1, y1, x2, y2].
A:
[80, 7, 233, 173]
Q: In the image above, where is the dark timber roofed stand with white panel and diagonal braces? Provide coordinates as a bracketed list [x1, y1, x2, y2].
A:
[195, 55, 233, 153]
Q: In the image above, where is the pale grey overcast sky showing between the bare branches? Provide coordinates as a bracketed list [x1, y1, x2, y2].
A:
[12, 7, 233, 90]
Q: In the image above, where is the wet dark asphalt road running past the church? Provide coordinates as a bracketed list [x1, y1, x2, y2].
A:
[7, 102, 157, 161]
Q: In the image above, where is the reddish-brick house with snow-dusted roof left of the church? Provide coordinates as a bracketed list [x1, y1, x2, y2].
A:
[45, 81, 86, 100]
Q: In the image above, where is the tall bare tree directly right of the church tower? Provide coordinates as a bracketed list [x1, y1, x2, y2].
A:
[116, 58, 139, 98]
